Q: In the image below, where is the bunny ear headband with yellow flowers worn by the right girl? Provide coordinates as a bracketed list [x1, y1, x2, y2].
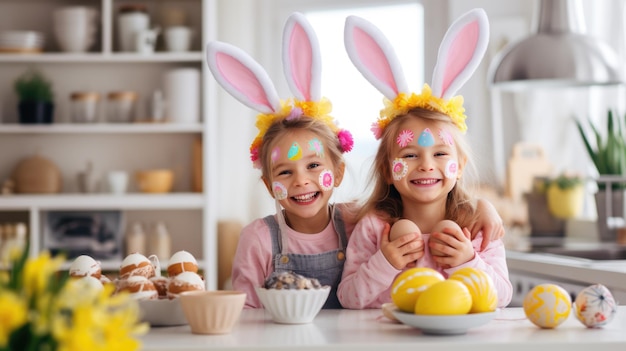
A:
[344, 9, 489, 139]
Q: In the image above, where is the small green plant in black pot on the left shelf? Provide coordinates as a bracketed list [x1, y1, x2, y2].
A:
[14, 69, 54, 124]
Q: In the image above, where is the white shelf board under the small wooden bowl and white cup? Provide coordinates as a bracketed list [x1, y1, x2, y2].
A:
[0, 193, 205, 211]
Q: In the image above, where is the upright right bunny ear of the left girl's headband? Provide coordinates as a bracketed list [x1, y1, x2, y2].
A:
[283, 12, 322, 101]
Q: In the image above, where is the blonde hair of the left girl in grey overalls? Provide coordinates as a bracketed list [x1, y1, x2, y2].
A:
[259, 117, 344, 181]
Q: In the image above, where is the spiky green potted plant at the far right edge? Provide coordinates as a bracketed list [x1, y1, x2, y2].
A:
[575, 110, 626, 241]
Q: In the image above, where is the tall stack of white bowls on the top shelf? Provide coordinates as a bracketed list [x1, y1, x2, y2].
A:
[53, 6, 98, 52]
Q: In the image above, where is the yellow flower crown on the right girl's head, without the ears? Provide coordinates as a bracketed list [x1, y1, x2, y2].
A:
[372, 84, 467, 139]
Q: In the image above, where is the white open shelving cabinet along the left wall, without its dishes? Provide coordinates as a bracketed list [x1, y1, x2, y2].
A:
[0, 0, 217, 289]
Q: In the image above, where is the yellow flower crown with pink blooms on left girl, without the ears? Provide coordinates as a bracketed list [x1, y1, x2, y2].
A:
[250, 98, 354, 168]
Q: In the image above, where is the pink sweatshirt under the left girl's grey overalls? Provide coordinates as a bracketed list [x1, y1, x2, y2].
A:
[232, 204, 354, 308]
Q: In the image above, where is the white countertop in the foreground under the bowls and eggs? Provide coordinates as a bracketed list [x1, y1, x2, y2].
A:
[142, 306, 626, 351]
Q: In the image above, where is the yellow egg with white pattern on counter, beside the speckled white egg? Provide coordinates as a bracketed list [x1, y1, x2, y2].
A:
[523, 284, 572, 329]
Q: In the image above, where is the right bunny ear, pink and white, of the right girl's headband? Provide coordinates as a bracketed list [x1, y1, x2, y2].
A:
[432, 9, 489, 100]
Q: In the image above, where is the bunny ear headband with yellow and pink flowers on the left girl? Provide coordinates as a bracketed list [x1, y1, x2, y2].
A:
[207, 13, 353, 168]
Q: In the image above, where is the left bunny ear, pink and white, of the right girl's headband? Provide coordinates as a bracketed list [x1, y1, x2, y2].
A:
[344, 16, 408, 101]
